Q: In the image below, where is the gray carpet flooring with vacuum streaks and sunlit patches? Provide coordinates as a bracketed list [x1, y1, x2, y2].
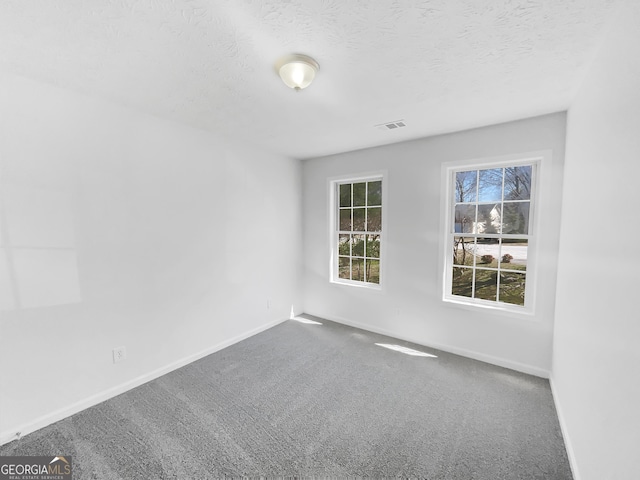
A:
[0, 317, 572, 480]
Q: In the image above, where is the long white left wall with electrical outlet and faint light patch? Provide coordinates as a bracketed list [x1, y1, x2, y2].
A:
[0, 76, 301, 442]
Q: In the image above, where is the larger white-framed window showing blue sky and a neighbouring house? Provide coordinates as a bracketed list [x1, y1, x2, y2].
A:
[444, 160, 539, 311]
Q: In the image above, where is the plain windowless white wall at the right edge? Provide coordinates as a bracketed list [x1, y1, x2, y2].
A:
[552, 0, 640, 480]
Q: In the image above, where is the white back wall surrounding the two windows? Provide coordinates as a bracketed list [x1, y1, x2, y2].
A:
[303, 112, 566, 376]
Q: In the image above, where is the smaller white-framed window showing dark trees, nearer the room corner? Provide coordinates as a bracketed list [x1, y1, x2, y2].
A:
[331, 176, 383, 287]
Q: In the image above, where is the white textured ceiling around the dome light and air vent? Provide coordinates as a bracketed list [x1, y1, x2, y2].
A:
[0, 0, 621, 158]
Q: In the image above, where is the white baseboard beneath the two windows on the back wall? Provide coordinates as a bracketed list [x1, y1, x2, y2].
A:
[314, 312, 549, 378]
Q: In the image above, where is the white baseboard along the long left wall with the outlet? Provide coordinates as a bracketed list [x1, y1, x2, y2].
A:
[0, 318, 287, 445]
